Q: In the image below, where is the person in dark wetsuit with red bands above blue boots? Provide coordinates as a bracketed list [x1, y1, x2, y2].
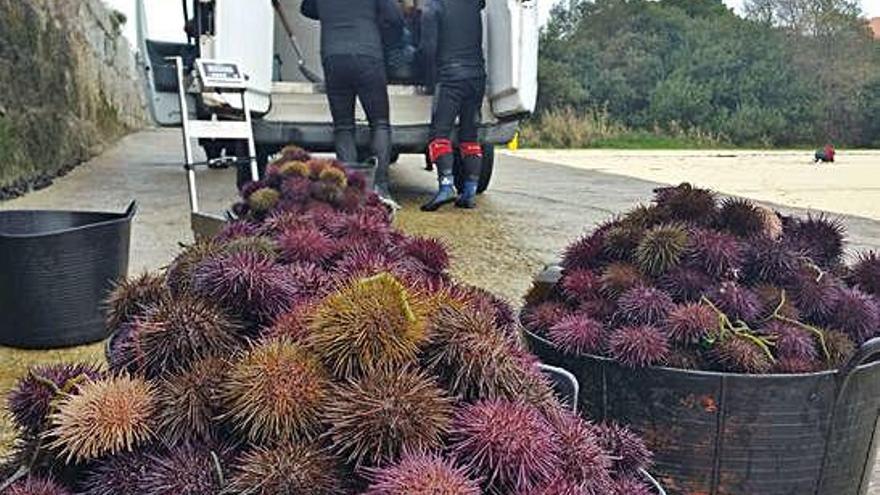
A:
[420, 0, 486, 211]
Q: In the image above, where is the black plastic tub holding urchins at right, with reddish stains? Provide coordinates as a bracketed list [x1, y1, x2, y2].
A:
[525, 326, 880, 495]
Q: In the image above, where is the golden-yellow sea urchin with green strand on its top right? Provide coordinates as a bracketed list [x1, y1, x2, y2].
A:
[307, 273, 429, 378]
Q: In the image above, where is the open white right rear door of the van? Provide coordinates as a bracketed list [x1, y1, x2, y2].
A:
[486, 0, 540, 119]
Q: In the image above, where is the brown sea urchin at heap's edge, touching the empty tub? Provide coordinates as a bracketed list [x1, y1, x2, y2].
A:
[104, 273, 168, 332]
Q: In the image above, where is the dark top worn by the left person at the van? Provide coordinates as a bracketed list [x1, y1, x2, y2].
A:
[300, 0, 404, 59]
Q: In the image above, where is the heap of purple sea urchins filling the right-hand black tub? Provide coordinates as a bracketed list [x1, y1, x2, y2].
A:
[523, 184, 880, 373]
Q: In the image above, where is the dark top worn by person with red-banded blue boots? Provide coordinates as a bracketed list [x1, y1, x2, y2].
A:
[419, 0, 486, 86]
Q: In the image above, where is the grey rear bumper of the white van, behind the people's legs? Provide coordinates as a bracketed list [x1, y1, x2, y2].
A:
[253, 119, 520, 153]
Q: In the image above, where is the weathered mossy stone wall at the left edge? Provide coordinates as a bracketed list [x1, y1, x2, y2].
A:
[0, 0, 146, 199]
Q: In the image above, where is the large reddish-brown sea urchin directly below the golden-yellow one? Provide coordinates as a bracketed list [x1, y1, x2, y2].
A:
[324, 370, 453, 466]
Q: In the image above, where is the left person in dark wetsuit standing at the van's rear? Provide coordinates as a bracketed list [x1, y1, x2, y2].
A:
[300, 0, 404, 200]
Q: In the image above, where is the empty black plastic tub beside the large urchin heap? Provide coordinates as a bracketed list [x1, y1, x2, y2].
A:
[0, 202, 137, 349]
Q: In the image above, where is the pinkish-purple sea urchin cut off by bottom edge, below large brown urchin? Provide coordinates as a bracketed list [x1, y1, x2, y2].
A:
[363, 454, 482, 495]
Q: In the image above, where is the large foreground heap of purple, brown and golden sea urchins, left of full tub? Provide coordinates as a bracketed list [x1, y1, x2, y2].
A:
[0, 148, 651, 495]
